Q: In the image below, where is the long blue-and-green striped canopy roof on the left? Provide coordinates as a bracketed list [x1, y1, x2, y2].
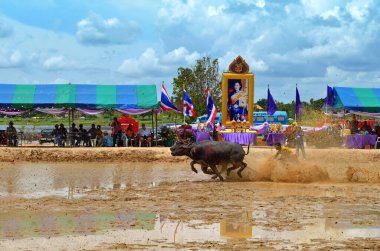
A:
[0, 84, 158, 110]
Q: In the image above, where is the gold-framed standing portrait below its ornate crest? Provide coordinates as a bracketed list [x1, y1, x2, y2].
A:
[222, 73, 254, 127]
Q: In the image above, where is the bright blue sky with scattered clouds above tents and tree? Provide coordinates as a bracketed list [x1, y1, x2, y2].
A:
[0, 0, 380, 102]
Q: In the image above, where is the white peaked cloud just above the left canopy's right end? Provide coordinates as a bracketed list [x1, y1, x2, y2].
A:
[117, 48, 169, 77]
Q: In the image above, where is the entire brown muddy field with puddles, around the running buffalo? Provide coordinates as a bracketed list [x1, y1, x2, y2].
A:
[0, 148, 380, 250]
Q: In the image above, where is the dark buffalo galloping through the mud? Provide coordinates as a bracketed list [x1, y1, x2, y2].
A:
[170, 141, 249, 181]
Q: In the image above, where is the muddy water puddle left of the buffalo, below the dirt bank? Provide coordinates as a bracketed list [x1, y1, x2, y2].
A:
[0, 163, 209, 199]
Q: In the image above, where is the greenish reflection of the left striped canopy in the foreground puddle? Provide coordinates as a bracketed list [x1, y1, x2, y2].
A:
[0, 211, 156, 239]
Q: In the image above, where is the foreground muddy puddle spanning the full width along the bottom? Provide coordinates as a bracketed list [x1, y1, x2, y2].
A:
[0, 207, 380, 250]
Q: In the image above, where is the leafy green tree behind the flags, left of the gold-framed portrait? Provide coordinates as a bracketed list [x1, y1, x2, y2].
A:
[173, 57, 222, 121]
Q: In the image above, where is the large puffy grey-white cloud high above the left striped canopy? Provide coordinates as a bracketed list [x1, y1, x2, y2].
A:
[76, 13, 139, 45]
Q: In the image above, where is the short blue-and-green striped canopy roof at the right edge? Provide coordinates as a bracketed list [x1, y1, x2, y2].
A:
[333, 87, 380, 114]
